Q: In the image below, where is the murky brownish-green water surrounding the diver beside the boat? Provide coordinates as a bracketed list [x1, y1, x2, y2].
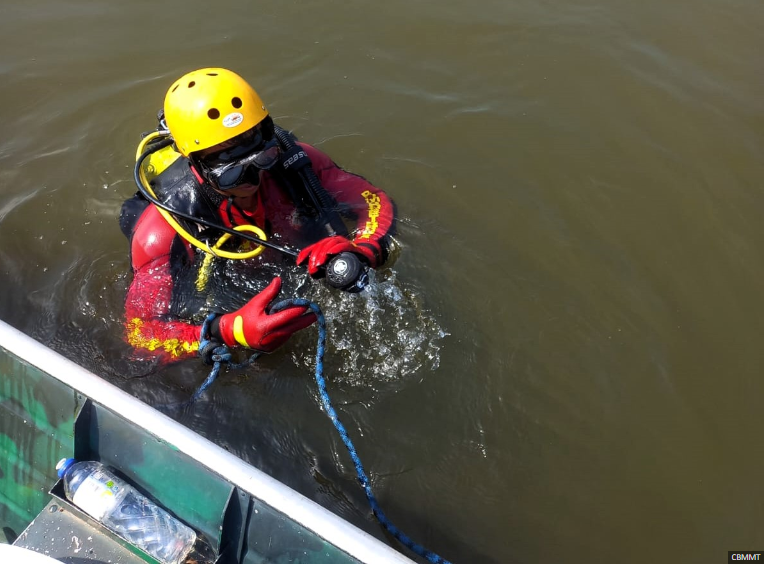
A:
[0, 0, 764, 564]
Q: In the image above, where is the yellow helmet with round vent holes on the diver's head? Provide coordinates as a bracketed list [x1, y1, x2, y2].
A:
[164, 68, 268, 157]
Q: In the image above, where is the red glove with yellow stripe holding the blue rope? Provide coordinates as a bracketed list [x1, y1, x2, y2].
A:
[210, 277, 316, 352]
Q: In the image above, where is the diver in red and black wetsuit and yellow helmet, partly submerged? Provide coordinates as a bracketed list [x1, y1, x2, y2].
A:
[120, 68, 395, 361]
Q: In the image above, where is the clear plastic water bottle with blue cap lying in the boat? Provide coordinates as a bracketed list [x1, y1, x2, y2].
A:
[56, 458, 196, 564]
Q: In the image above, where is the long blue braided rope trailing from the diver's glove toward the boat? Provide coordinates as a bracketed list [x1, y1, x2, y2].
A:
[271, 298, 450, 564]
